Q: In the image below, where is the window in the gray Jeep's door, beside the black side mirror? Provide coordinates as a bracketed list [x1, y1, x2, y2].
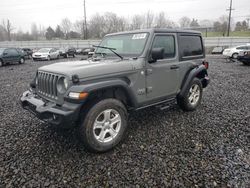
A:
[153, 35, 176, 59]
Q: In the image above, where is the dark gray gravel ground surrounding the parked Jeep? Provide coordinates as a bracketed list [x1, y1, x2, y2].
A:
[0, 55, 250, 188]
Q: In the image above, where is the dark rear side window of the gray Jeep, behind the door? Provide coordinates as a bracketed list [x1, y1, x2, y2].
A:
[179, 35, 204, 60]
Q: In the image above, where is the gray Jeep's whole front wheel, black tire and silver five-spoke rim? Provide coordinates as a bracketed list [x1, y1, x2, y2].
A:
[79, 99, 127, 152]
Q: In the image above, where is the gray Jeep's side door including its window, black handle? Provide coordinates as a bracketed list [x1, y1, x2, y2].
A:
[146, 33, 179, 99]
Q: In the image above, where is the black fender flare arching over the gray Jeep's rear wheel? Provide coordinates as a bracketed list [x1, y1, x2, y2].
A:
[178, 65, 207, 97]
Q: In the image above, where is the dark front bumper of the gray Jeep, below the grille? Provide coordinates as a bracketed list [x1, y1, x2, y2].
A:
[20, 91, 82, 127]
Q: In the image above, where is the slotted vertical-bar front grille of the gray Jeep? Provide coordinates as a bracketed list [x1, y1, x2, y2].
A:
[37, 71, 59, 99]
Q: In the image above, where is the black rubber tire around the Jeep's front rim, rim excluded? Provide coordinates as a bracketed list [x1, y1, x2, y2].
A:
[79, 98, 127, 153]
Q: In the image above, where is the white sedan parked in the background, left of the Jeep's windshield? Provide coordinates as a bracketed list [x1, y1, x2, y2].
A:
[32, 48, 59, 61]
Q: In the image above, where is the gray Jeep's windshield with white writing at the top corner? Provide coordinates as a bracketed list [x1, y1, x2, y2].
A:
[96, 33, 148, 57]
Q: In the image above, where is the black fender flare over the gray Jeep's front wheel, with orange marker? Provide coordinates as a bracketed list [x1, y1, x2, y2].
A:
[67, 78, 138, 107]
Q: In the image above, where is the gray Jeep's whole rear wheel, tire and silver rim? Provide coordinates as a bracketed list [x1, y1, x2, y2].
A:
[177, 78, 202, 111]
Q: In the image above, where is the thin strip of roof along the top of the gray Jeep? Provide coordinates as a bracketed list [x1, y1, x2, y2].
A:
[106, 28, 201, 36]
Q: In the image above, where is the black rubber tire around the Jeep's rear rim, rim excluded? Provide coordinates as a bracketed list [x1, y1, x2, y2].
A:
[177, 78, 202, 111]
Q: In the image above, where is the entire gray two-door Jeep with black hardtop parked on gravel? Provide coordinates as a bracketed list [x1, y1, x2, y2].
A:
[21, 29, 209, 152]
